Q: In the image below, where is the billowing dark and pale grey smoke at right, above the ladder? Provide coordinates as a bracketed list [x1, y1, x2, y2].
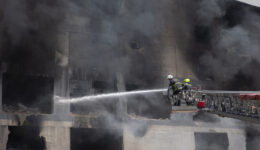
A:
[188, 0, 260, 90]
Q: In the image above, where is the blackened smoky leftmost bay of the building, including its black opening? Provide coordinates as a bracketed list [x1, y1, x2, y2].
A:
[0, 0, 67, 113]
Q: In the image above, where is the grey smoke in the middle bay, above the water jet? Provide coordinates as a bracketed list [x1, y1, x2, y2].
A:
[68, 0, 165, 88]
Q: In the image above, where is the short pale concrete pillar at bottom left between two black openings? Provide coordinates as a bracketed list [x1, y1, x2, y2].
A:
[40, 127, 70, 150]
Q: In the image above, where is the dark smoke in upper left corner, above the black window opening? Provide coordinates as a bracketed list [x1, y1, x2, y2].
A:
[0, 0, 66, 73]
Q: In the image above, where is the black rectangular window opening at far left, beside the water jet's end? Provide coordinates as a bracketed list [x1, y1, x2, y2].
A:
[2, 73, 54, 113]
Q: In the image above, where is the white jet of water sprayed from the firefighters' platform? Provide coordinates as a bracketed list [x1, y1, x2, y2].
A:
[55, 89, 167, 103]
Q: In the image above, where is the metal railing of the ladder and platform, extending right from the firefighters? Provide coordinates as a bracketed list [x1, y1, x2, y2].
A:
[168, 87, 260, 118]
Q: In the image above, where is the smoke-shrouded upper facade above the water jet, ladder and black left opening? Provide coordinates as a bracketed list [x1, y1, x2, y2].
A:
[0, 0, 259, 115]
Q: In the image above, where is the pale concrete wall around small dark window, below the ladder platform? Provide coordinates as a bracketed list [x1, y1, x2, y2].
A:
[123, 125, 246, 150]
